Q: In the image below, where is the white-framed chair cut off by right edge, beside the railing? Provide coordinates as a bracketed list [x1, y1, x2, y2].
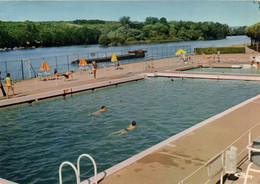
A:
[244, 139, 260, 184]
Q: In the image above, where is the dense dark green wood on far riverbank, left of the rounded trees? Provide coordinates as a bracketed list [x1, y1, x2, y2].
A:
[0, 21, 101, 48]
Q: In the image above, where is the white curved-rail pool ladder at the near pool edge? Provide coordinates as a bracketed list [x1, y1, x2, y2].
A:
[59, 154, 97, 184]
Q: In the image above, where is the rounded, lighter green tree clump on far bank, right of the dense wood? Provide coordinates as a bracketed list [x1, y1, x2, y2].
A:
[99, 17, 229, 45]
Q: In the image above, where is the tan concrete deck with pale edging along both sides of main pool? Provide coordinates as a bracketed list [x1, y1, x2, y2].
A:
[0, 52, 260, 184]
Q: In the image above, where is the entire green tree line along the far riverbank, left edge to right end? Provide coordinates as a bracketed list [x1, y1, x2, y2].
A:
[0, 16, 247, 48]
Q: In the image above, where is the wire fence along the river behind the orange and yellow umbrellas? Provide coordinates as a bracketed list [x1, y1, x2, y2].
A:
[0, 45, 193, 80]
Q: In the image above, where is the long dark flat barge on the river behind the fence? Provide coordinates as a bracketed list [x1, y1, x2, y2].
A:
[71, 49, 147, 64]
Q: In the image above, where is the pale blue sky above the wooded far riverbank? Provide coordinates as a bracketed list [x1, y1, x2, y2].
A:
[0, 0, 260, 26]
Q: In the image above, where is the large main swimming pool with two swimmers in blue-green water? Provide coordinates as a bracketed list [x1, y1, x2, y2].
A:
[0, 78, 260, 184]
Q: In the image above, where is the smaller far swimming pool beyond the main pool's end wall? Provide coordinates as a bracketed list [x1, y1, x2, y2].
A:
[186, 65, 260, 74]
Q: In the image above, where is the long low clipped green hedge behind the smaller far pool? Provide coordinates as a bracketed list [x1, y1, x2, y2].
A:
[194, 47, 245, 54]
